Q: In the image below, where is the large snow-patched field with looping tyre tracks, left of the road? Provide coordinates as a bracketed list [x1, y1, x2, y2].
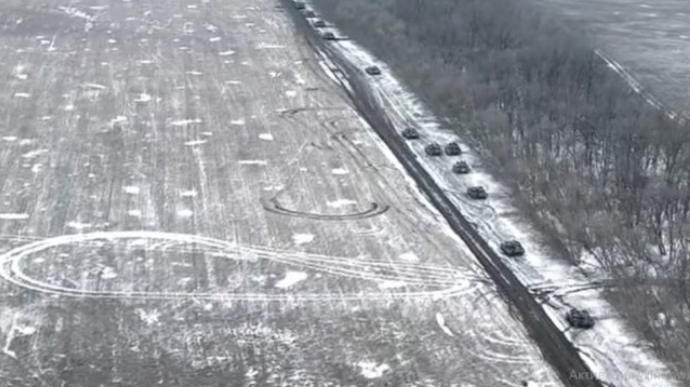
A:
[0, 0, 560, 387]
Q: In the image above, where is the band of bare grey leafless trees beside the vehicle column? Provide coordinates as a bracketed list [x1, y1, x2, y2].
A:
[315, 0, 690, 371]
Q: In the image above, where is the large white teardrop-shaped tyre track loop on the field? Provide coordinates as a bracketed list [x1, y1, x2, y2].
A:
[0, 231, 472, 302]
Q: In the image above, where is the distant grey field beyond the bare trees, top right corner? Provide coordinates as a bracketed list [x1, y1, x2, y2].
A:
[531, 0, 690, 114]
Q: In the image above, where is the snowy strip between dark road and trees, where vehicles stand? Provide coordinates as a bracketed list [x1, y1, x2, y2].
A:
[318, 23, 680, 387]
